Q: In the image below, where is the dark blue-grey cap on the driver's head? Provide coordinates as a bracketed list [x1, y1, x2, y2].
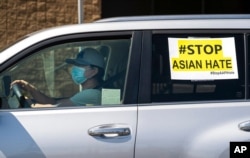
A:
[65, 48, 104, 69]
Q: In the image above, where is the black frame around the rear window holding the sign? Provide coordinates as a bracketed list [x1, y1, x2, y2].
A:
[138, 29, 250, 106]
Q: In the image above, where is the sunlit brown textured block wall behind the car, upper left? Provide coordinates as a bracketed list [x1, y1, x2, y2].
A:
[0, 0, 101, 49]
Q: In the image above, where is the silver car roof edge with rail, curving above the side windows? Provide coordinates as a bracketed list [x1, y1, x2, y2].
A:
[0, 15, 250, 64]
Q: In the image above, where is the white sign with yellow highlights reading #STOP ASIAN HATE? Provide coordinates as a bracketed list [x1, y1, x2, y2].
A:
[168, 37, 238, 80]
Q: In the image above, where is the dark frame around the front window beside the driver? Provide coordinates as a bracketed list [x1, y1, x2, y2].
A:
[0, 31, 142, 110]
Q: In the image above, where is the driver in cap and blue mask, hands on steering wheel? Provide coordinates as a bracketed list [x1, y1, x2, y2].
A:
[11, 48, 104, 108]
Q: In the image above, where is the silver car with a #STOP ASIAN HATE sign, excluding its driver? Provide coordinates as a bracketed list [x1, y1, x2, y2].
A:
[0, 15, 250, 158]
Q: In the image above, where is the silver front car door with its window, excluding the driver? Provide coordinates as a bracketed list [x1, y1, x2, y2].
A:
[0, 32, 141, 158]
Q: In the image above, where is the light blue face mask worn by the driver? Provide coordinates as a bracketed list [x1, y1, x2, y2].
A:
[71, 66, 87, 84]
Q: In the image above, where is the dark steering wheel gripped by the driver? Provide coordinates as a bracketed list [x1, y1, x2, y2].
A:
[12, 84, 30, 108]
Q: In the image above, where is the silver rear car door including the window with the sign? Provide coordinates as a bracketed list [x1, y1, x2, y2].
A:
[135, 30, 250, 158]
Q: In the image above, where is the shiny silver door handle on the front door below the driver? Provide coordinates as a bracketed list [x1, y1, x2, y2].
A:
[88, 124, 131, 138]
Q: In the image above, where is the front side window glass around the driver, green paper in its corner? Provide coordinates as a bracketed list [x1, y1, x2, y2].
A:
[0, 36, 131, 108]
